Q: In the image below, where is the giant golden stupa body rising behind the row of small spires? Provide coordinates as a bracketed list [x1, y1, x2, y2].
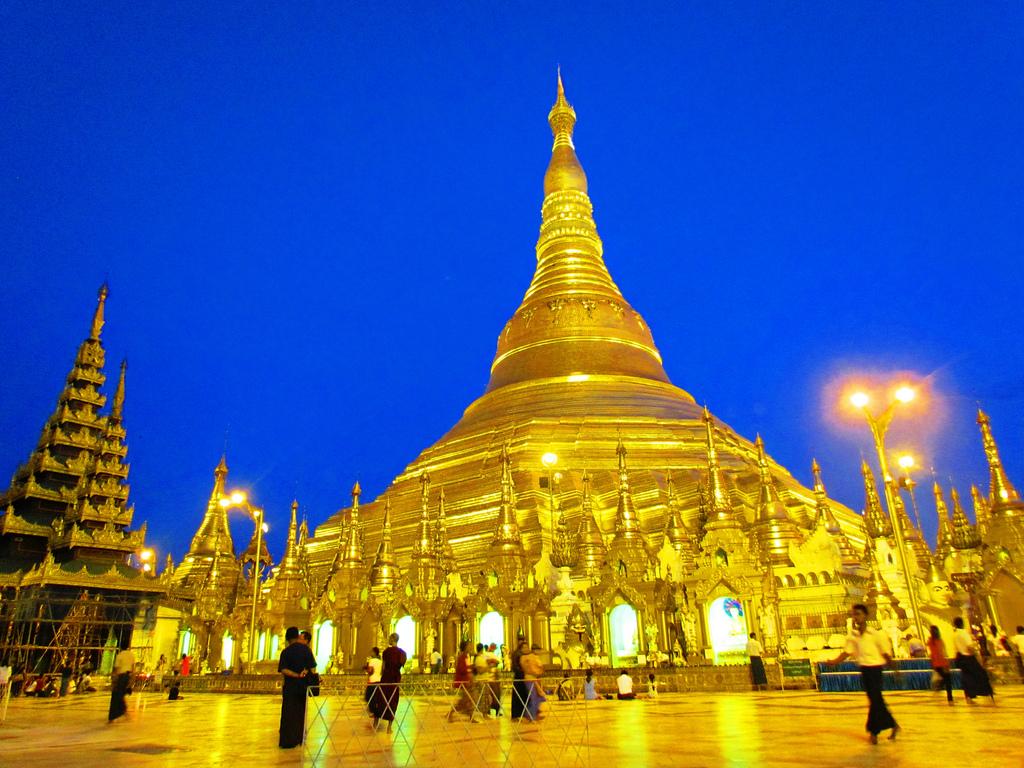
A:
[308, 76, 863, 602]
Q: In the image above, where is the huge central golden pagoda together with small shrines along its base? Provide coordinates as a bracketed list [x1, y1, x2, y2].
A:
[296, 76, 868, 665]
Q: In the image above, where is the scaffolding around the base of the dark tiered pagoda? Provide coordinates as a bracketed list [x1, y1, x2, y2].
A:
[0, 585, 146, 673]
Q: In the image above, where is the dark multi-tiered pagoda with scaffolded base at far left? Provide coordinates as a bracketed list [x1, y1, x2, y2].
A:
[0, 284, 166, 670]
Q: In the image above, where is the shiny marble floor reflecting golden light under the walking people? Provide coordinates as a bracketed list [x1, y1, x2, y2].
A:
[0, 686, 1024, 768]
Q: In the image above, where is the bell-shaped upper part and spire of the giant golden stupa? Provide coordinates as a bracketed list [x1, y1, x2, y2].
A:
[487, 75, 669, 392]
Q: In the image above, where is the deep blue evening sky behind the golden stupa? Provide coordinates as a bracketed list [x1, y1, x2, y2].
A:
[0, 0, 1024, 558]
